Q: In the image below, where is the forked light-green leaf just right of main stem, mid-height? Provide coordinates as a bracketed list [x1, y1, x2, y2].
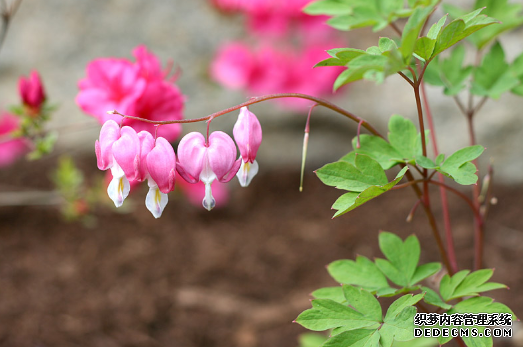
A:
[437, 145, 484, 185]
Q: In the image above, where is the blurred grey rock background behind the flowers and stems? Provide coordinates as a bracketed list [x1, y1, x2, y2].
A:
[0, 0, 523, 183]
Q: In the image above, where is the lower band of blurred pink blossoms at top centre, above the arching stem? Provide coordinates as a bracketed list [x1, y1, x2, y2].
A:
[210, 41, 343, 110]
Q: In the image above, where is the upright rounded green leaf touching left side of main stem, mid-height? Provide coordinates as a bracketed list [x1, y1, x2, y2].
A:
[389, 115, 418, 160]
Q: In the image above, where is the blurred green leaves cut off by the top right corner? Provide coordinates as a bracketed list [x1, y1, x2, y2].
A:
[443, 0, 523, 49]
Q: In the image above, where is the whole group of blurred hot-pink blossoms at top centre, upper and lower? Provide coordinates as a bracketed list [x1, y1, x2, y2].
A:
[210, 0, 345, 110]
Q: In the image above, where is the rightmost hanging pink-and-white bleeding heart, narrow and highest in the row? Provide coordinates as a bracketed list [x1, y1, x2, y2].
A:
[233, 107, 262, 187]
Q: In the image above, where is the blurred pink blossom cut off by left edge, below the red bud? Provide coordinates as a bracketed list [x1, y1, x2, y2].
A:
[0, 112, 29, 168]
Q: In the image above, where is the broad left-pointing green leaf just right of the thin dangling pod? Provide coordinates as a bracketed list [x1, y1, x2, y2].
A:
[316, 154, 388, 192]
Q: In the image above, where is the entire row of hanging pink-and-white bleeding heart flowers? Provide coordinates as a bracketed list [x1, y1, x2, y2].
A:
[95, 107, 262, 218]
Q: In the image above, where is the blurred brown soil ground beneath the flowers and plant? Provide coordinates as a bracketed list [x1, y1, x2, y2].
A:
[0, 158, 523, 347]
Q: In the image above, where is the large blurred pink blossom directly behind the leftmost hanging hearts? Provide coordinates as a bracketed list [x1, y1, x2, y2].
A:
[76, 45, 185, 141]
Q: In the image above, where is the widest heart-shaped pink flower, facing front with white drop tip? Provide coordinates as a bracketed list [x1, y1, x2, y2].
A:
[176, 131, 241, 211]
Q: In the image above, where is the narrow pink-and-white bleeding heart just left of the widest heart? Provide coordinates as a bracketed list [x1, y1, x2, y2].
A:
[145, 137, 176, 218]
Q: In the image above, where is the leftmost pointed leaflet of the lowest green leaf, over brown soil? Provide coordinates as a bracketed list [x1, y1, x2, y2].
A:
[296, 299, 379, 331]
